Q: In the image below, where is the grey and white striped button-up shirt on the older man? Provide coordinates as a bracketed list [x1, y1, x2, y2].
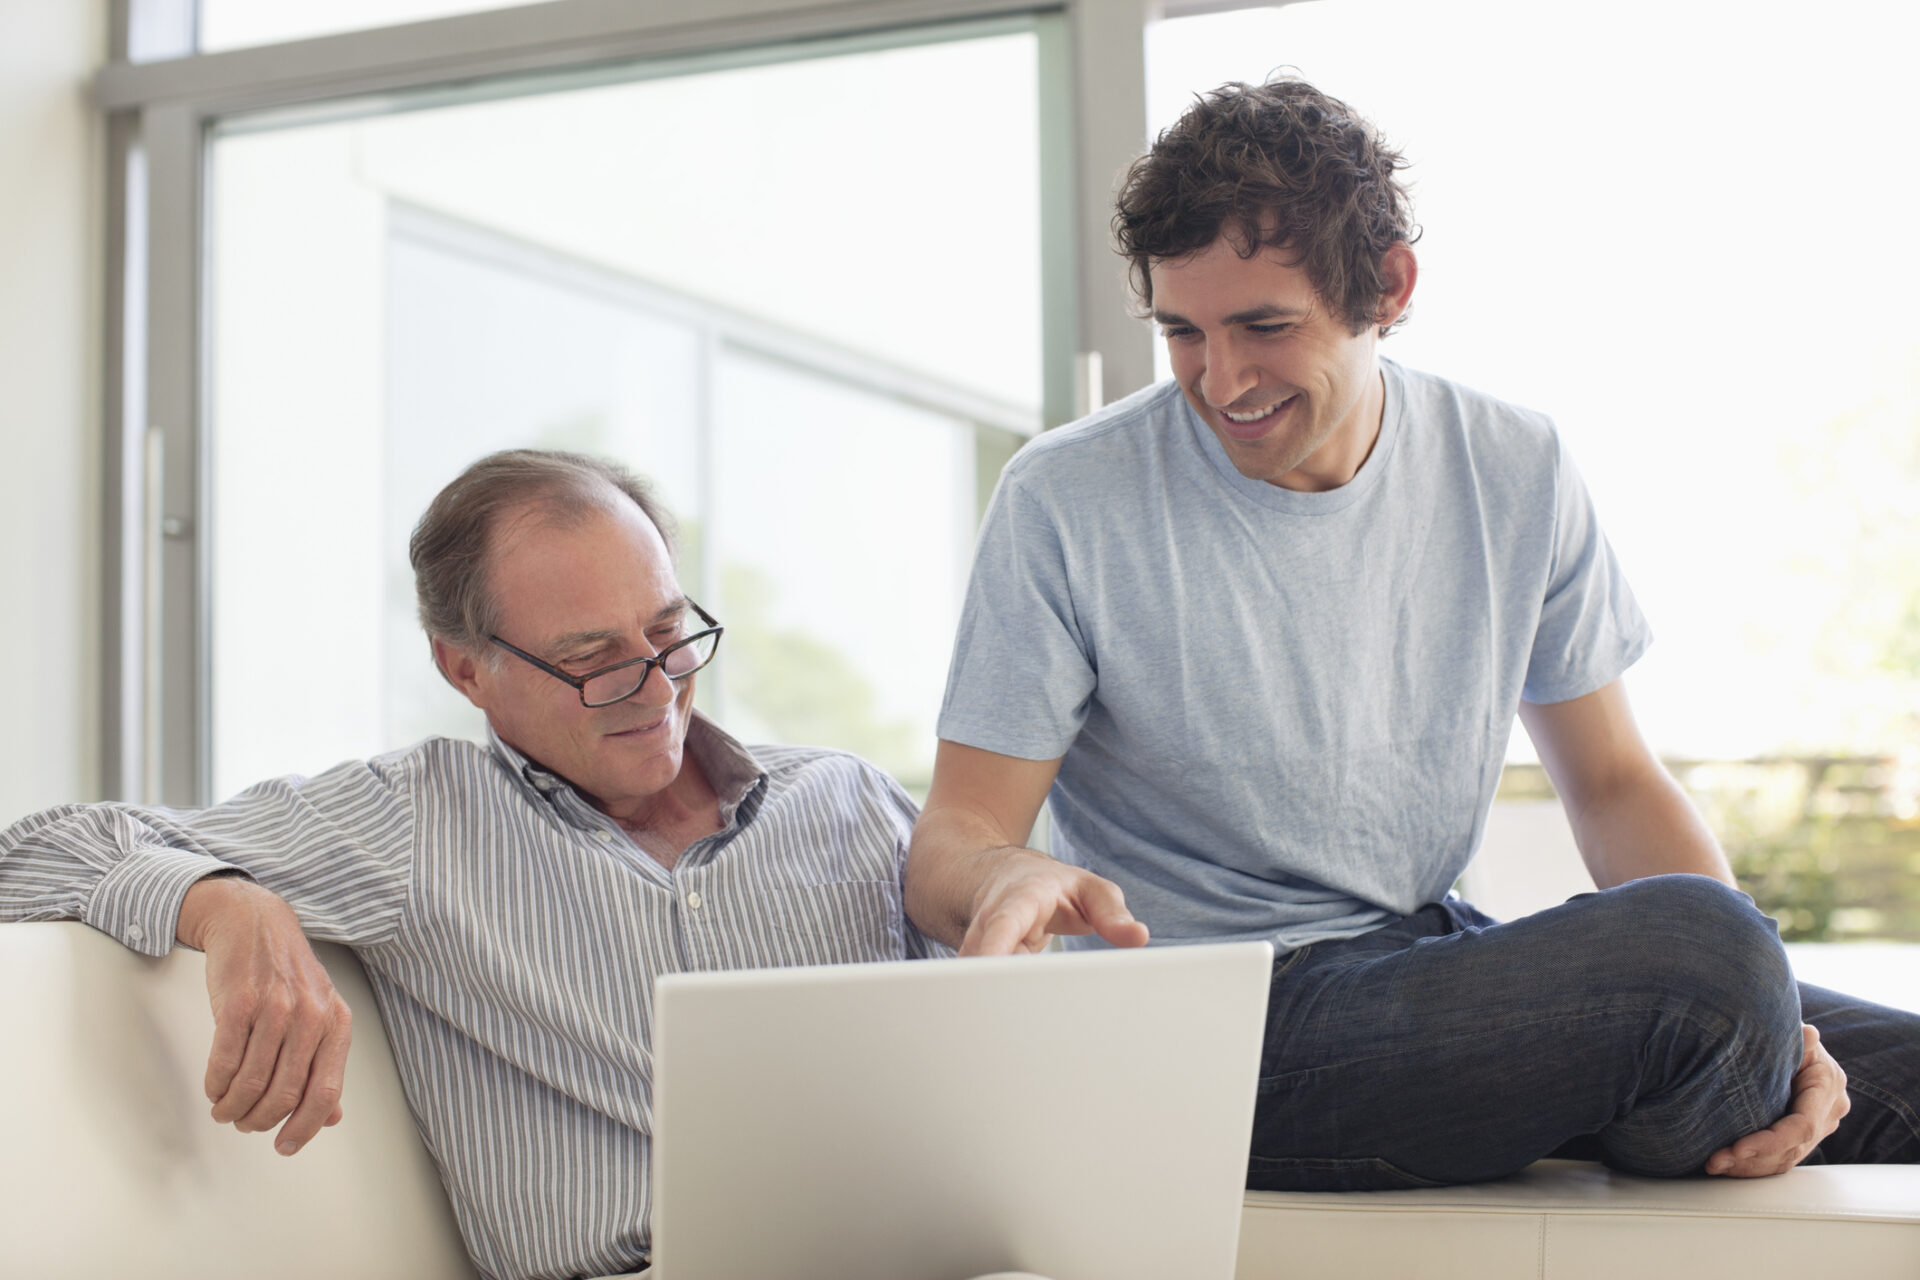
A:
[0, 716, 941, 1280]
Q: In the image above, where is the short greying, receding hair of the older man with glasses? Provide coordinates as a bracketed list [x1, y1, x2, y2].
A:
[407, 449, 674, 667]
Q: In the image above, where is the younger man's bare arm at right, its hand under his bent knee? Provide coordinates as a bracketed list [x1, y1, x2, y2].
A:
[1521, 681, 1851, 1178]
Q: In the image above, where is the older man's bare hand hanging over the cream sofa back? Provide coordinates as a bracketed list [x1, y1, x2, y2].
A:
[177, 877, 353, 1155]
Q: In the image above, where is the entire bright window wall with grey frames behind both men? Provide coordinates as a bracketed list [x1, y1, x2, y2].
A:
[108, 0, 1920, 959]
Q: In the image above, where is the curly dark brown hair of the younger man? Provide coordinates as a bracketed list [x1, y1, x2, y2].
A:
[1114, 75, 1419, 336]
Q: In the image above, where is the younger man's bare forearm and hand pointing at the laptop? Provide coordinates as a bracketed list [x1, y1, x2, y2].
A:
[904, 741, 1146, 956]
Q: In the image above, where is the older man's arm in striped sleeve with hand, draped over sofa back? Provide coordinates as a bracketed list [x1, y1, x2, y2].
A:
[0, 762, 415, 1155]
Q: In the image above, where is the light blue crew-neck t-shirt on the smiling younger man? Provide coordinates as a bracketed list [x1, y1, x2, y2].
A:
[939, 361, 1651, 948]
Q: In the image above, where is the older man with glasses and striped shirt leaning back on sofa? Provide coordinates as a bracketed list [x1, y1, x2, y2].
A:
[0, 451, 929, 1278]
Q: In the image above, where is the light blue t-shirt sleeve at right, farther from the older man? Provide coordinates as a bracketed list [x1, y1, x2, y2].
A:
[1521, 441, 1653, 702]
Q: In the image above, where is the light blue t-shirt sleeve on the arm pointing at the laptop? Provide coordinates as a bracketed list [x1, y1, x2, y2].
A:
[939, 461, 1096, 760]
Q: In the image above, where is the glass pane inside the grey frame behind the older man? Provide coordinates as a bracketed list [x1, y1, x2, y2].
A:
[209, 31, 1043, 794]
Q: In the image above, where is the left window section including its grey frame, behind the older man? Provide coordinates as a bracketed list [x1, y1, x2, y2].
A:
[108, 0, 1152, 804]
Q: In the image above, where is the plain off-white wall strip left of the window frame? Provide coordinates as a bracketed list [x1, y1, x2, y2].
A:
[0, 0, 106, 825]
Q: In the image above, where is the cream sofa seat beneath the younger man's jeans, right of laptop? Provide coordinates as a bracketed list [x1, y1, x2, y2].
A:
[1235, 1161, 1920, 1280]
